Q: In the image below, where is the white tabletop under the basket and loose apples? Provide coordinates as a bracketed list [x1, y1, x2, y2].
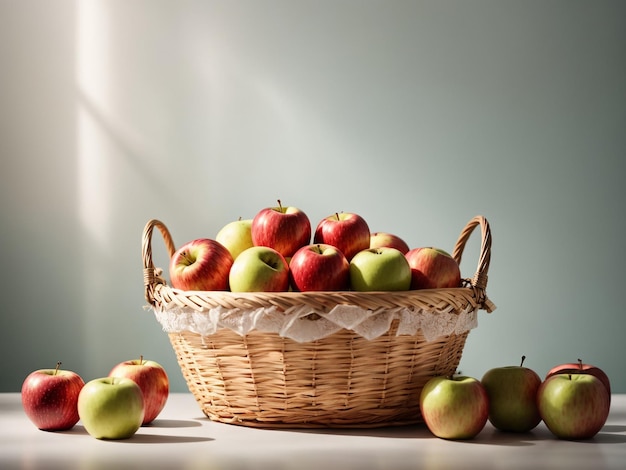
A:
[0, 393, 626, 470]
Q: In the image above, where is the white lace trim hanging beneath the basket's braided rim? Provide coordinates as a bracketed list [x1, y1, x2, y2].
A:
[149, 304, 478, 343]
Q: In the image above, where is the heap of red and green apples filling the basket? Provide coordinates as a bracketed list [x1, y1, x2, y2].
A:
[170, 200, 461, 292]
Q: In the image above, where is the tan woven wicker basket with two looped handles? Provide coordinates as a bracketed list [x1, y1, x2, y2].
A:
[142, 216, 495, 428]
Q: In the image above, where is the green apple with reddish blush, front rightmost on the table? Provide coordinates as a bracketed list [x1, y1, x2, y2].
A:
[537, 374, 610, 440]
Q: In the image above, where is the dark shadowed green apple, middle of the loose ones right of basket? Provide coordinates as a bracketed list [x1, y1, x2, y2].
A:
[481, 356, 541, 432]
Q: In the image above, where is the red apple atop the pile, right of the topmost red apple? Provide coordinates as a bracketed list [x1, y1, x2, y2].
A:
[313, 212, 370, 261]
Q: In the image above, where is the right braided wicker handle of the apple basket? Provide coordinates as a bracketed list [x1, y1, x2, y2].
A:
[452, 215, 496, 313]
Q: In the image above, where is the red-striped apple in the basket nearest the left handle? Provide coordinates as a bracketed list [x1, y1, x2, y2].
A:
[170, 238, 233, 291]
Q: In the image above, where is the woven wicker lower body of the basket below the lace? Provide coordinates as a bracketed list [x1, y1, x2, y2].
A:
[169, 327, 468, 428]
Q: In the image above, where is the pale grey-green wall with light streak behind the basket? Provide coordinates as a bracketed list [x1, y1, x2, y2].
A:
[0, 0, 626, 393]
